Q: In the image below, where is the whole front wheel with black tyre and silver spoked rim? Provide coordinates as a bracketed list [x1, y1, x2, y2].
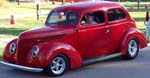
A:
[47, 54, 69, 76]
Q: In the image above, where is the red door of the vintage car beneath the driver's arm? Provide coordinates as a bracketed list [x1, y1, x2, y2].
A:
[78, 11, 110, 58]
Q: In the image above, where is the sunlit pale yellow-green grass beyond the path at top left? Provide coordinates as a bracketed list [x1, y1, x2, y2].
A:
[0, 2, 61, 15]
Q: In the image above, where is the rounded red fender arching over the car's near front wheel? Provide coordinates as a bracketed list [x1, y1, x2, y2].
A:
[34, 42, 82, 68]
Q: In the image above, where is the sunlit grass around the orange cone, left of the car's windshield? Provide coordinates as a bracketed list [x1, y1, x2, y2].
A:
[0, 16, 46, 37]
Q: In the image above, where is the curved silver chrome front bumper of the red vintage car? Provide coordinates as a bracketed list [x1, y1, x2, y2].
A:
[0, 61, 43, 72]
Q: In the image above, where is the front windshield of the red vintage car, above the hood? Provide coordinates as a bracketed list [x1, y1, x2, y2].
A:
[46, 11, 77, 25]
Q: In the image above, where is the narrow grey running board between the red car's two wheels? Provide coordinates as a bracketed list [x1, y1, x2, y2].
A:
[83, 52, 122, 65]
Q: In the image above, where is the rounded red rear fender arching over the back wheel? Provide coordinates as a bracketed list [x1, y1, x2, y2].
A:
[121, 28, 147, 55]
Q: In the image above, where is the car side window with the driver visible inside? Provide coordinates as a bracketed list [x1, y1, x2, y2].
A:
[81, 12, 105, 25]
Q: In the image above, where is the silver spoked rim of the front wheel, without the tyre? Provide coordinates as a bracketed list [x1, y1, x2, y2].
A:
[51, 57, 66, 74]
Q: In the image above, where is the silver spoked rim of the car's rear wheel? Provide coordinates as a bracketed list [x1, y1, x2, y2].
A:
[128, 40, 138, 56]
